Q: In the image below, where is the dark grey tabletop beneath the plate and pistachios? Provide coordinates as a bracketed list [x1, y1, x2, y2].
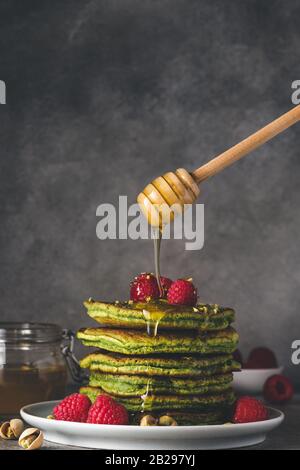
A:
[0, 395, 300, 450]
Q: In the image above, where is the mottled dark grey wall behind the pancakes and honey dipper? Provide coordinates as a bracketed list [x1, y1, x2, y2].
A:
[0, 0, 300, 386]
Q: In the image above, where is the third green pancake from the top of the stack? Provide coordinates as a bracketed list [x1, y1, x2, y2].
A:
[80, 352, 240, 377]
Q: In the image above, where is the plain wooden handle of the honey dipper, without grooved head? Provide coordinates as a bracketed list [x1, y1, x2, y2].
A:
[192, 105, 300, 183]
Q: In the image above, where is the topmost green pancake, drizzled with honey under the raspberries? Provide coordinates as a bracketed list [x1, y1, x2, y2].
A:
[84, 299, 234, 333]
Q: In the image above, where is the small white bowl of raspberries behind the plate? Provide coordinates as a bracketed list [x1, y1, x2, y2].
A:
[233, 367, 283, 395]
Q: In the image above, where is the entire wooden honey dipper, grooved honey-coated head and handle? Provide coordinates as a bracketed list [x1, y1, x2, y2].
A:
[137, 105, 300, 228]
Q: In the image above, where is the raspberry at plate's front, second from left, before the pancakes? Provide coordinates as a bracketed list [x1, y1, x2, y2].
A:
[87, 395, 129, 424]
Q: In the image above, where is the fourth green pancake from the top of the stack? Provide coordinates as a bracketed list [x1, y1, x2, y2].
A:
[89, 372, 233, 397]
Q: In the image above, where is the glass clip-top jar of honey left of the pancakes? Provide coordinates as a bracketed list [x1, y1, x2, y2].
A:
[0, 322, 76, 416]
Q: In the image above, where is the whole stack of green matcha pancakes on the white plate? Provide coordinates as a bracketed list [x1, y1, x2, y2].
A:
[77, 300, 240, 424]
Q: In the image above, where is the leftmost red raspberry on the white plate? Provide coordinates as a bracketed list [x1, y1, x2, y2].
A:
[53, 393, 91, 423]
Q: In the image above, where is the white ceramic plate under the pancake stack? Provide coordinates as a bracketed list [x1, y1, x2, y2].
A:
[21, 401, 284, 450]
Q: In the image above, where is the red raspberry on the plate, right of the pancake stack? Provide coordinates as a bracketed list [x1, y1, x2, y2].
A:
[233, 396, 268, 424]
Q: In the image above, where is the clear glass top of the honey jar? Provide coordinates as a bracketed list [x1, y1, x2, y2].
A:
[0, 322, 62, 343]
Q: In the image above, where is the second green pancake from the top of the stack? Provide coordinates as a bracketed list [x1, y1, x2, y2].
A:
[77, 327, 239, 355]
